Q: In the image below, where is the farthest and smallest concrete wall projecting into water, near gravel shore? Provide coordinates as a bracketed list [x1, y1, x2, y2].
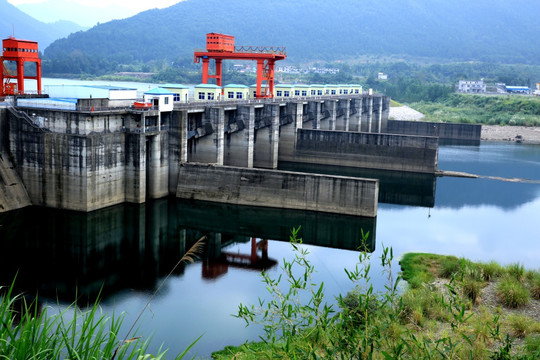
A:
[388, 120, 482, 145]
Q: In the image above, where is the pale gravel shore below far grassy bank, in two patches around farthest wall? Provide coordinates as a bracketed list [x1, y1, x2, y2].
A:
[390, 106, 540, 144]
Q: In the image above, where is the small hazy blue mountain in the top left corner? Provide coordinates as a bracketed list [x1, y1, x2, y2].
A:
[0, 0, 82, 50]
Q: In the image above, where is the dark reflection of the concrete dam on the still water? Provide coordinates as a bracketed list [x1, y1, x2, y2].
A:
[0, 199, 375, 302]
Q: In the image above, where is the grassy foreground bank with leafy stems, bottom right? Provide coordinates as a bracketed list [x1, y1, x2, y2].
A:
[213, 236, 540, 359]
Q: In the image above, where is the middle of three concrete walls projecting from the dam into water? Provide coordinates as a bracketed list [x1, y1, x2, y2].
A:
[286, 129, 438, 173]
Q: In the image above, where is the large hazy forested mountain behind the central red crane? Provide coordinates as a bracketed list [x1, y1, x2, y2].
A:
[45, 0, 540, 73]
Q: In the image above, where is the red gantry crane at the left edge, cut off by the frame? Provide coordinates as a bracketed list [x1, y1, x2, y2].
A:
[0, 36, 41, 96]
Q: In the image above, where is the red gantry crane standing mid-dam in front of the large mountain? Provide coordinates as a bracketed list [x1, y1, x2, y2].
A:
[194, 33, 287, 98]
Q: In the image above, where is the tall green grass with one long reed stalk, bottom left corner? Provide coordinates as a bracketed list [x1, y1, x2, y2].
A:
[0, 237, 204, 360]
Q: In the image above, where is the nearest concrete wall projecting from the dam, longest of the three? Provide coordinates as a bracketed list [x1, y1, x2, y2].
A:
[176, 163, 379, 217]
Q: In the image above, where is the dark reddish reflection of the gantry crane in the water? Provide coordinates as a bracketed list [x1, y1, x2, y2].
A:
[202, 237, 277, 279]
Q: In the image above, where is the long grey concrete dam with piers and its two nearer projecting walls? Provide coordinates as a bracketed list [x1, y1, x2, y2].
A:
[0, 94, 479, 217]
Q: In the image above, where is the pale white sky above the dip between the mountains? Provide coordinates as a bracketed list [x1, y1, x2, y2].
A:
[8, 0, 182, 27]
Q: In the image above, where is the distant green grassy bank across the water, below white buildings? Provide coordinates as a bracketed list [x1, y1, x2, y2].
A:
[409, 94, 540, 126]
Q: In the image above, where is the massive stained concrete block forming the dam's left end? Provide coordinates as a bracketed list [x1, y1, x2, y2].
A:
[9, 106, 169, 212]
